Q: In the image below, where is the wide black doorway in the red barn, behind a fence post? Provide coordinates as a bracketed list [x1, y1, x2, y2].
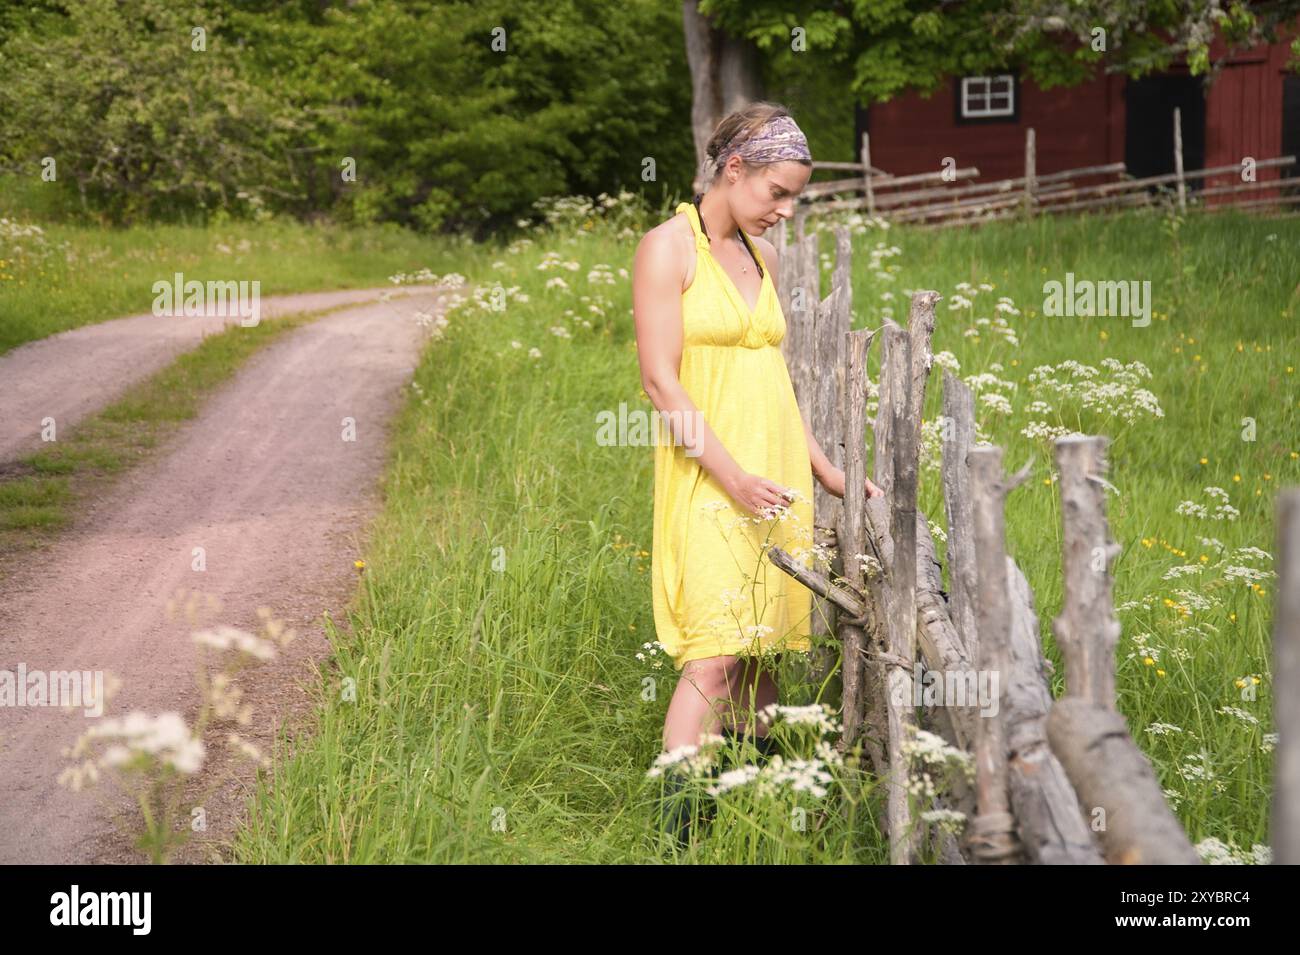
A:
[1125, 73, 1205, 188]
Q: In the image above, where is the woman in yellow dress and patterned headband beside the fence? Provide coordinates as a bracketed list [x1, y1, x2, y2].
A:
[632, 103, 883, 841]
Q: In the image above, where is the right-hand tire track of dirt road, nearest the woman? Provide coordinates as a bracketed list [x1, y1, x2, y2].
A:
[0, 292, 449, 863]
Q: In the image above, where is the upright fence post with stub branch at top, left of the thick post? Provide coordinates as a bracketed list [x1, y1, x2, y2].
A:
[967, 447, 1030, 864]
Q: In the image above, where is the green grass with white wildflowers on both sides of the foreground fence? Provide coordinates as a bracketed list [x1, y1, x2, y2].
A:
[235, 197, 1300, 863]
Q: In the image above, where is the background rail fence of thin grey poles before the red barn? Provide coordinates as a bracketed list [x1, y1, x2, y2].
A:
[796, 128, 1300, 234]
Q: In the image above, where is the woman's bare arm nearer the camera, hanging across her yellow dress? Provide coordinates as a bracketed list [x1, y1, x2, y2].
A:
[632, 229, 789, 513]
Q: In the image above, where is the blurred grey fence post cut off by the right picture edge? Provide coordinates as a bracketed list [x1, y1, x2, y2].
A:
[1270, 487, 1300, 865]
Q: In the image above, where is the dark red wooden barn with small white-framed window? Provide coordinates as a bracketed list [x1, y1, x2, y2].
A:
[858, 30, 1300, 194]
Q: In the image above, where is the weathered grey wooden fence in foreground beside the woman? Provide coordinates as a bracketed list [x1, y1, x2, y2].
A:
[771, 227, 1300, 864]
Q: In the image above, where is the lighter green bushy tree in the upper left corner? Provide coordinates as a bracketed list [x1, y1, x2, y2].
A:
[0, 0, 303, 220]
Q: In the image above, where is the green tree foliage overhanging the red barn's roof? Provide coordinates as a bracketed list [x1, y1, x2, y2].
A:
[699, 0, 1300, 104]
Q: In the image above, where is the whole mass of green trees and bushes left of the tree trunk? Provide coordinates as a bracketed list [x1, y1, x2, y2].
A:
[0, 0, 694, 230]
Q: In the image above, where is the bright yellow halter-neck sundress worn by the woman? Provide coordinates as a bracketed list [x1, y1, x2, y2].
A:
[650, 203, 813, 670]
